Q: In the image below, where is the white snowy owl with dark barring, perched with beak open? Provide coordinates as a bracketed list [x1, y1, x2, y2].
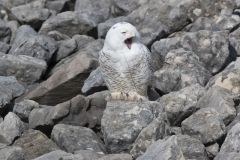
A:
[99, 22, 152, 101]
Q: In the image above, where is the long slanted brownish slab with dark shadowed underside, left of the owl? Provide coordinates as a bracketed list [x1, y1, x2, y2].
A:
[25, 54, 98, 105]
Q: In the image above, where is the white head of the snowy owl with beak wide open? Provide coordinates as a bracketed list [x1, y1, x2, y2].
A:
[104, 22, 140, 50]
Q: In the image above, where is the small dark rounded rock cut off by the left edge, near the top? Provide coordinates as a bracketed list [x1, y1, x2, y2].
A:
[0, 19, 11, 43]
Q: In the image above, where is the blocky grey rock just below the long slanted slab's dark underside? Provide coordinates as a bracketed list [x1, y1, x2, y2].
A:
[29, 101, 71, 128]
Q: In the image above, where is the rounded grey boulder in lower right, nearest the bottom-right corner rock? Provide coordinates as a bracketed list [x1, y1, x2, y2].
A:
[182, 108, 226, 144]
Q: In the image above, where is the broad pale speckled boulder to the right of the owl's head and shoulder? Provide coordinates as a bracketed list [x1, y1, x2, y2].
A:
[151, 30, 231, 74]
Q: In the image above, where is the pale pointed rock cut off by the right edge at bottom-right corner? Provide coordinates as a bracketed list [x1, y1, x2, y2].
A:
[220, 123, 240, 153]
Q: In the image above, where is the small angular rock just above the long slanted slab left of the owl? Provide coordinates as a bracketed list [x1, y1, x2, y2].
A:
[55, 39, 77, 62]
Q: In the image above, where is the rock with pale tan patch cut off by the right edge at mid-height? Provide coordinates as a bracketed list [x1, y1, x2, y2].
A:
[207, 58, 240, 94]
